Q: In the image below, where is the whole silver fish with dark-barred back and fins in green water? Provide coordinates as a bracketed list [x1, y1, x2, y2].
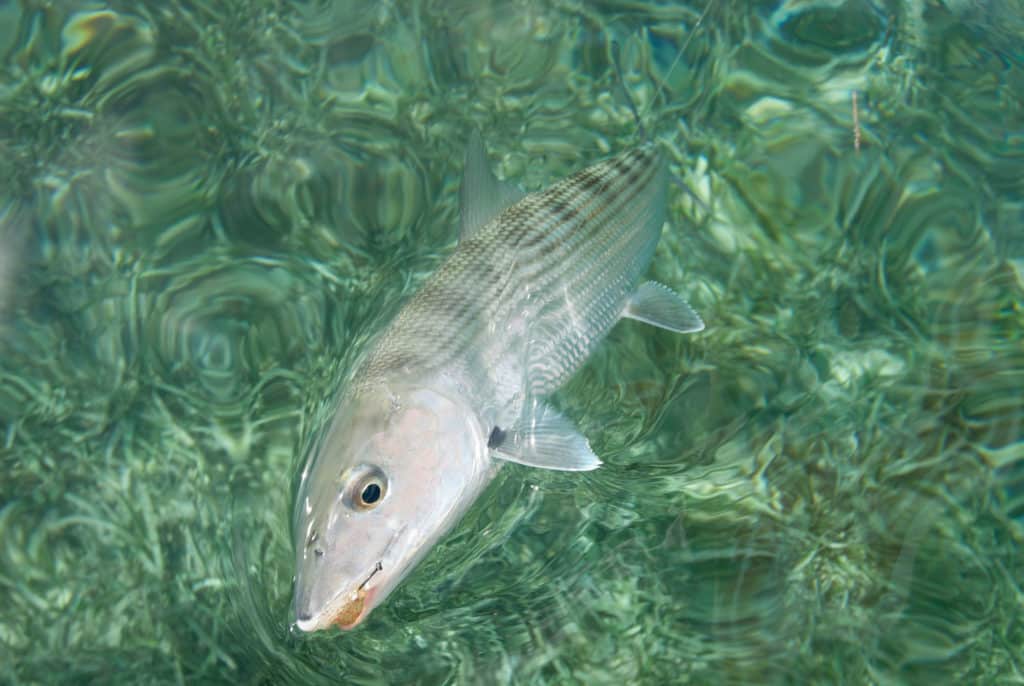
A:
[294, 134, 703, 631]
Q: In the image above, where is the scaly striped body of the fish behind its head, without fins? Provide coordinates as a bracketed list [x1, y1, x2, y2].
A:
[361, 144, 666, 401]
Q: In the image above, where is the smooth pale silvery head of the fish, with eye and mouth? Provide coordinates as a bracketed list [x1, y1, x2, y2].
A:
[294, 384, 493, 632]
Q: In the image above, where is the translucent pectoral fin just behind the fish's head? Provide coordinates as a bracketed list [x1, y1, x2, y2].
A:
[488, 405, 601, 472]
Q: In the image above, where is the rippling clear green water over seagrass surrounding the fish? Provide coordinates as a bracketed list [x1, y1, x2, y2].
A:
[0, 0, 1024, 684]
